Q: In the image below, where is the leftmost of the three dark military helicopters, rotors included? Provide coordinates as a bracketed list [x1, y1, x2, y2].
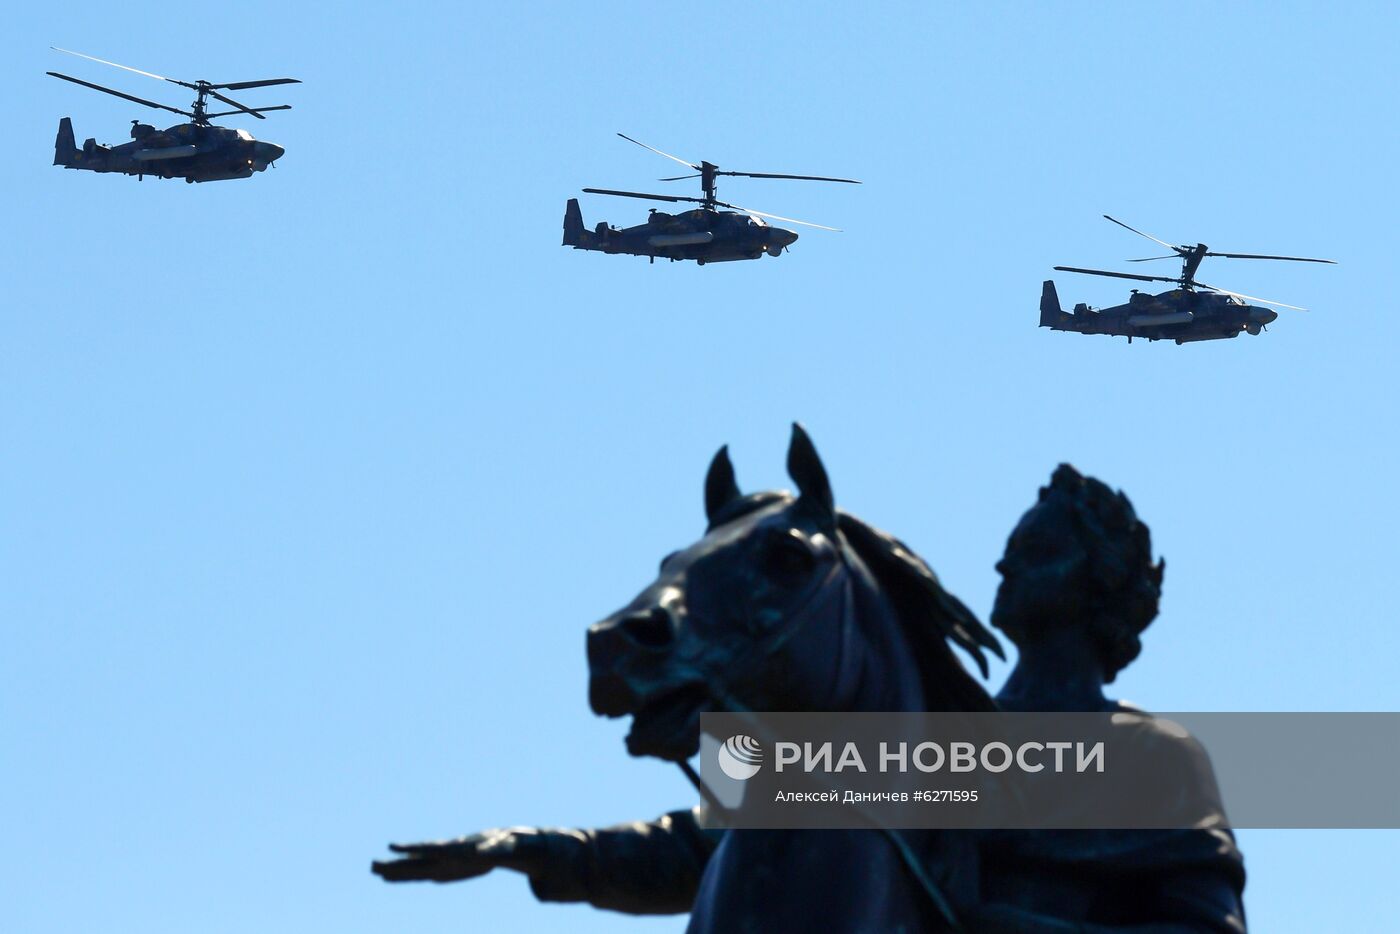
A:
[48, 48, 301, 183]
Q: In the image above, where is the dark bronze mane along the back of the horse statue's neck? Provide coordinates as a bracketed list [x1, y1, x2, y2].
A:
[837, 511, 1005, 711]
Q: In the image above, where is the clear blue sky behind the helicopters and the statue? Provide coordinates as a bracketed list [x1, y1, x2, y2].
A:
[0, 0, 1400, 934]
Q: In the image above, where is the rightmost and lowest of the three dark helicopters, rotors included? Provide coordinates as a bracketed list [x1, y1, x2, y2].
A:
[1040, 214, 1336, 344]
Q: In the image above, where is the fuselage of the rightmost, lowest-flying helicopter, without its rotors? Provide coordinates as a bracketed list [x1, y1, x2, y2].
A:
[1040, 285, 1278, 344]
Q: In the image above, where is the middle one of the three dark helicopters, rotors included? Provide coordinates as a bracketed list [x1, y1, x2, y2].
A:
[563, 133, 860, 266]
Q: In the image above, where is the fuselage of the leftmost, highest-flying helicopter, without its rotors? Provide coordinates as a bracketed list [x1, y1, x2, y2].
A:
[53, 118, 284, 182]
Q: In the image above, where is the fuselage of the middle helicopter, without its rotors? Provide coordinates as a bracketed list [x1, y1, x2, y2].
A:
[563, 197, 798, 266]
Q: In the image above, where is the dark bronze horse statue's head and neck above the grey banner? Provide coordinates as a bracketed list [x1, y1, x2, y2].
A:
[588, 424, 1001, 762]
